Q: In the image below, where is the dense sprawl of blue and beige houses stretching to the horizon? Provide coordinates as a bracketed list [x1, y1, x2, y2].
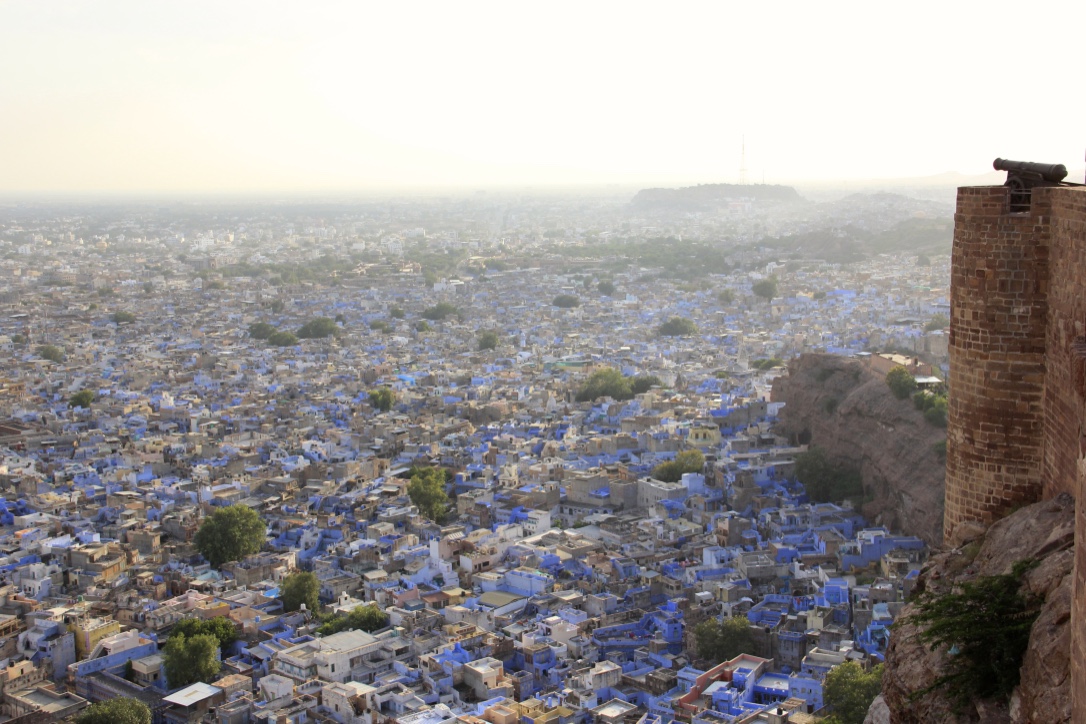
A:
[0, 186, 951, 724]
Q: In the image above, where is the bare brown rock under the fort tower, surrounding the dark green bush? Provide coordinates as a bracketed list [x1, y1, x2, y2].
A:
[883, 494, 1075, 724]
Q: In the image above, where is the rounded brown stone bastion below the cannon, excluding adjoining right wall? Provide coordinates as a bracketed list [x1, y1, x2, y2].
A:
[944, 187, 1050, 539]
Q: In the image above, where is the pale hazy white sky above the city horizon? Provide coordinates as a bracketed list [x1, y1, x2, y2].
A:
[0, 0, 1086, 192]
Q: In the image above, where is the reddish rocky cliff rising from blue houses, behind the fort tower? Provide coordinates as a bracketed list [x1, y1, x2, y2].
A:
[773, 354, 946, 546]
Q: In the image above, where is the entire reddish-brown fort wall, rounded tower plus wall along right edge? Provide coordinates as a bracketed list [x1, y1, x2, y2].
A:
[944, 182, 1086, 722]
